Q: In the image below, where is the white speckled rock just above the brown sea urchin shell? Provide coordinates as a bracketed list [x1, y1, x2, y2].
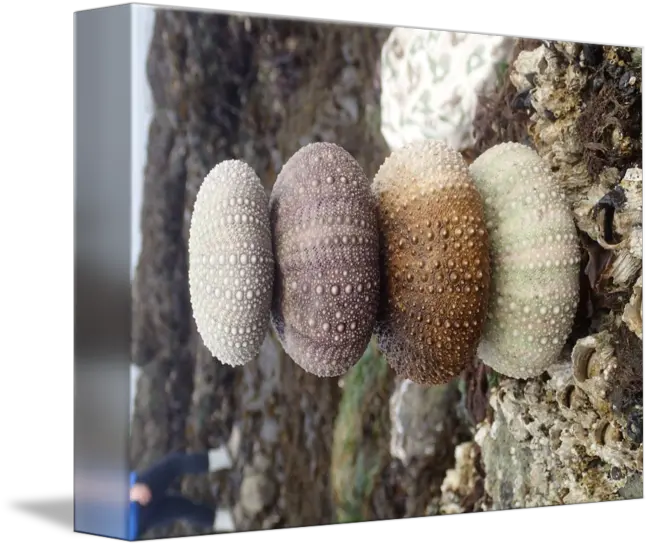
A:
[381, 28, 515, 150]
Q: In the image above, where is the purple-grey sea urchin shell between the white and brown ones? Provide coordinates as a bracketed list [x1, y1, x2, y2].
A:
[270, 143, 379, 377]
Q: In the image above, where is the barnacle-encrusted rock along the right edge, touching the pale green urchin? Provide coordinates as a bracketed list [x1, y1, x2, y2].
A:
[458, 42, 643, 509]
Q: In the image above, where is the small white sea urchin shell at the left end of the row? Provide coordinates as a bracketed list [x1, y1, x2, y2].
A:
[188, 160, 274, 366]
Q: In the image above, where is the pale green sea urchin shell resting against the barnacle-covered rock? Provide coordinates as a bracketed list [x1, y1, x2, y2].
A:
[470, 143, 580, 379]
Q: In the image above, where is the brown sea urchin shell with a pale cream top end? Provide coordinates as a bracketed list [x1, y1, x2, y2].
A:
[372, 140, 490, 385]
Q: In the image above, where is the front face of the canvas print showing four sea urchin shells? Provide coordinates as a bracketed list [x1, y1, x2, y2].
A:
[123, 10, 643, 538]
